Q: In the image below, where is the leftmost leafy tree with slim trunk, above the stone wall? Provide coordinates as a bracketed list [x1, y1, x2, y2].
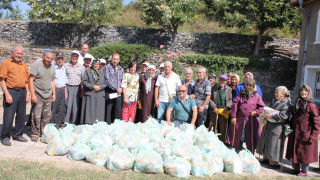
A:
[22, 0, 122, 45]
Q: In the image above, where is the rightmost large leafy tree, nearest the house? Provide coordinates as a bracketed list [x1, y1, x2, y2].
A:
[204, 0, 298, 56]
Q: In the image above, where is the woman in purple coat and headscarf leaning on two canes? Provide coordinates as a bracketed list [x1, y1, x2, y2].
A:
[226, 79, 265, 153]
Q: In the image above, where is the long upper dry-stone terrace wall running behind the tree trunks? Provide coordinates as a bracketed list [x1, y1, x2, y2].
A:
[0, 21, 299, 54]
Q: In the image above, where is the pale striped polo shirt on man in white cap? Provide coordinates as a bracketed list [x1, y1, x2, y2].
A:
[63, 62, 84, 86]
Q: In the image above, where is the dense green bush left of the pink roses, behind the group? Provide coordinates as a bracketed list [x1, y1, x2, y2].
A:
[89, 42, 162, 68]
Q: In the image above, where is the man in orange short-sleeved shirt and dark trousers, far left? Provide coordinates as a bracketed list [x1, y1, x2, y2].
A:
[0, 46, 30, 146]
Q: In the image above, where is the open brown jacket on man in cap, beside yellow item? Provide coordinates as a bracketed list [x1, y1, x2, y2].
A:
[209, 83, 232, 109]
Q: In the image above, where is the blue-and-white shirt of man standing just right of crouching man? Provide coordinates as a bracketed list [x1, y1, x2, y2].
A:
[194, 79, 211, 109]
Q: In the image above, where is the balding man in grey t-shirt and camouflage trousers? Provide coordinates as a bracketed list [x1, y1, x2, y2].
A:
[29, 51, 56, 142]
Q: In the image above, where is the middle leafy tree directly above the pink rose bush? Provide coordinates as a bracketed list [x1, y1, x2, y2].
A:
[141, 0, 199, 49]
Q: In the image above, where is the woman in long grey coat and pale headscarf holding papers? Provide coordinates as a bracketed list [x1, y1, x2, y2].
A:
[257, 86, 291, 167]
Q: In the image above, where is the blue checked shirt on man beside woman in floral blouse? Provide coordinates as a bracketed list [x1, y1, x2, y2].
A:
[104, 64, 124, 91]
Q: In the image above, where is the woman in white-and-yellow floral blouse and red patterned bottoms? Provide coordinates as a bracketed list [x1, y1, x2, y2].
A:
[121, 61, 139, 122]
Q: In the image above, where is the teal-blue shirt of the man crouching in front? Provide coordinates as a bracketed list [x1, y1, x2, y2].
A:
[168, 96, 197, 122]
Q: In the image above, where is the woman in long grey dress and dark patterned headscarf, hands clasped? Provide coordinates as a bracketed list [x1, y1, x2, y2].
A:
[80, 59, 107, 124]
